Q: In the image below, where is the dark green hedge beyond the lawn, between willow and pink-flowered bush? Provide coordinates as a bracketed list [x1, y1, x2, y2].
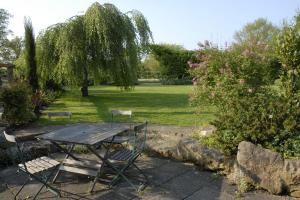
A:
[150, 44, 194, 79]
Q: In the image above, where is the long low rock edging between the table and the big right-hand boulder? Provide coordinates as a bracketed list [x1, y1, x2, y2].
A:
[146, 126, 234, 174]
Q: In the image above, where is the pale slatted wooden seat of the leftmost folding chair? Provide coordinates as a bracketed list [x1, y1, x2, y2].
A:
[19, 156, 60, 174]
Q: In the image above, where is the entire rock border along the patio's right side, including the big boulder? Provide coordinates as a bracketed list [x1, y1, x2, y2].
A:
[147, 127, 300, 197]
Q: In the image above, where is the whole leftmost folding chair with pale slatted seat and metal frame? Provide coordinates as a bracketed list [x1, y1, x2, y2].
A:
[3, 131, 61, 199]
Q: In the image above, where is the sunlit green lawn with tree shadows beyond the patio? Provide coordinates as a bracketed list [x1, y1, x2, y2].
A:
[38, 86, 214, 126]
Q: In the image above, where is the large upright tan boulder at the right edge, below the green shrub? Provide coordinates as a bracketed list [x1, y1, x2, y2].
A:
[236, 141, 300, 197]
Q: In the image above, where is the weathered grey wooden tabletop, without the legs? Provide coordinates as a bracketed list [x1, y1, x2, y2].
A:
[37, 124, 129, 145]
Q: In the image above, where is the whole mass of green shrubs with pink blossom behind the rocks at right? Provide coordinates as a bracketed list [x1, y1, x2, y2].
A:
[191, 18, 300, 156]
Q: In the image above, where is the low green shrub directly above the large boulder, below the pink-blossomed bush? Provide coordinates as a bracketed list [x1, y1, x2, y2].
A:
[201, 88, 300, 156]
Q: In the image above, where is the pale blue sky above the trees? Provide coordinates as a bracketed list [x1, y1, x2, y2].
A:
[0, 0, 300, 49]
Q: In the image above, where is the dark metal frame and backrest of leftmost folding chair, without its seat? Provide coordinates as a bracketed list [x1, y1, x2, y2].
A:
[3, 131, 61, 200]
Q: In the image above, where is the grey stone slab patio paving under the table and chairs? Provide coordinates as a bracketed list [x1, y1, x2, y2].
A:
[0, 154, 295, 200]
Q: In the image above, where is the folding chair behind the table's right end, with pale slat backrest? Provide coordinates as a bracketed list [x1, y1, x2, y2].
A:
[104, 110, 132, 144]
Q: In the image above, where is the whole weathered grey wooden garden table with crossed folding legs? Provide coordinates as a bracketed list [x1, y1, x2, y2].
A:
[37, 124, 129, 192]
